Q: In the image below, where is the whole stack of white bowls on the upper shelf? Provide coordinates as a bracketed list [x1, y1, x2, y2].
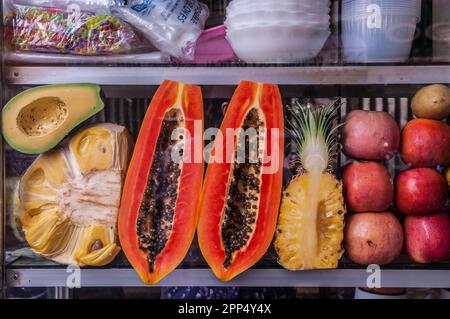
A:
[225, 0, 330, 63]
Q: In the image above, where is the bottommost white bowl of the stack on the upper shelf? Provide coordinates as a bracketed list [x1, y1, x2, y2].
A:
[227, 26, 330, 63]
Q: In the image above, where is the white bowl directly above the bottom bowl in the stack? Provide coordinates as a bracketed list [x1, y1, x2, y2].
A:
[225, 10, 330, 27]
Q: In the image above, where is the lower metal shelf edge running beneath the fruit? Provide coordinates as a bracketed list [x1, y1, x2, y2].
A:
[7, 269, 450, 288]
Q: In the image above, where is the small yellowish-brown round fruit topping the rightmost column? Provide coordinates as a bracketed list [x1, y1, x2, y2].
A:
[411, 84, 450, 120]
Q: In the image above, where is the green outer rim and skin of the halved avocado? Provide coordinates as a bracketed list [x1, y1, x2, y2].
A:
[2, 83, 105, 154]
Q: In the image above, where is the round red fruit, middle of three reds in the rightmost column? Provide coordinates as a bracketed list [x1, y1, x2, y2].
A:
[395, 168, 448, 215]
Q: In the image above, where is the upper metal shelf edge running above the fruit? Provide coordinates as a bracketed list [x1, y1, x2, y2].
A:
[5, 65, 450, 85]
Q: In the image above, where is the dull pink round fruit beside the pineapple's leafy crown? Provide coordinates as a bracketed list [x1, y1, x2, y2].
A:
[342, 110, 400, 161]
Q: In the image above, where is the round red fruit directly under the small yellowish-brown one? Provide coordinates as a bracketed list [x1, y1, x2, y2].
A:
[401, 119, 450, 167]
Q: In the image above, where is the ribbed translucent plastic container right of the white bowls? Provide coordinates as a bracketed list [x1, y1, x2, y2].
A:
[342, 0, 421, 63]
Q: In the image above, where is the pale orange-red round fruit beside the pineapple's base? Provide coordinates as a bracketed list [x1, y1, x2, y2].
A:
[344, 212, 403, 265]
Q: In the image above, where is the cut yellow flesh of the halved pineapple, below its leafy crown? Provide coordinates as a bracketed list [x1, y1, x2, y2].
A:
[275, 173, 344, 270]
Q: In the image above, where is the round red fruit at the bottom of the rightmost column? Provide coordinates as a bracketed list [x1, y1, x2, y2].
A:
[405, 212, 450, 263]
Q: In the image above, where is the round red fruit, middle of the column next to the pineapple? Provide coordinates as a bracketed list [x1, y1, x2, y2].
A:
[342, 162, 394, 212]
